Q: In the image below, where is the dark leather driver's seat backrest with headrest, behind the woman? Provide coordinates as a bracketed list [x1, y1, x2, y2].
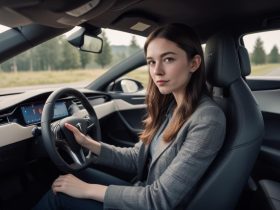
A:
[187, 32, 264, 210]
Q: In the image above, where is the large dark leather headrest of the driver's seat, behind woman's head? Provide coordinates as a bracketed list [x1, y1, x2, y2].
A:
[205, 32, 241, 87]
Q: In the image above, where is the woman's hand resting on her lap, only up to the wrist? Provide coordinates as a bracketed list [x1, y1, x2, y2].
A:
[52, 174, 93, 198]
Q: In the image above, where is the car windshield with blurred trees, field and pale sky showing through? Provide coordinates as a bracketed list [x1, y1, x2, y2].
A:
[0, 26, 145, 94]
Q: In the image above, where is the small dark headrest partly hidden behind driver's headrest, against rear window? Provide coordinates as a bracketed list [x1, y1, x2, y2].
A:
[238, 46, 251, 77]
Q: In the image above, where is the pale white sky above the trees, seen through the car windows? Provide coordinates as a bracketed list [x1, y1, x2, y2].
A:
[0, 25, 280, 54]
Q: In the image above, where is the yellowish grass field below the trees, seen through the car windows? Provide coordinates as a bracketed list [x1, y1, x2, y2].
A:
[0, 64, 280, 88]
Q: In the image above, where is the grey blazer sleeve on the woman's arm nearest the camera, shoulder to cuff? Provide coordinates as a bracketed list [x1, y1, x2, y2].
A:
[104, 106, 226, 210]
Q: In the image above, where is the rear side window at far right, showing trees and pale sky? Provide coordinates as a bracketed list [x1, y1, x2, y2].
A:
[243, 30, 280, 78]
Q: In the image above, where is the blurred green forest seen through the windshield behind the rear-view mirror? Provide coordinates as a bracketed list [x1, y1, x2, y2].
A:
[0, 32, 140, 72]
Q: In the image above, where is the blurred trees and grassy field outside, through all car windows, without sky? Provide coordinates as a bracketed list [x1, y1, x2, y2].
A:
[0, 33, 280, 92]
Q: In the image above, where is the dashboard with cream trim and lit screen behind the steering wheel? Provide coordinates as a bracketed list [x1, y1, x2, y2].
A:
[0, 90, 114, 176]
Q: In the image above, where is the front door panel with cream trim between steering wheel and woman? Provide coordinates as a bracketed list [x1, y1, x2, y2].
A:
[101, 93, 146, 147]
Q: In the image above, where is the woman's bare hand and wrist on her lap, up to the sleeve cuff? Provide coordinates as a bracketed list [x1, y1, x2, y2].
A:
[52, 174, 107, 202]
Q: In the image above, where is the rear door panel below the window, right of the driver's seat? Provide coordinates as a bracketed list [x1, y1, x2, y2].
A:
[248, 79, 280, 181]
